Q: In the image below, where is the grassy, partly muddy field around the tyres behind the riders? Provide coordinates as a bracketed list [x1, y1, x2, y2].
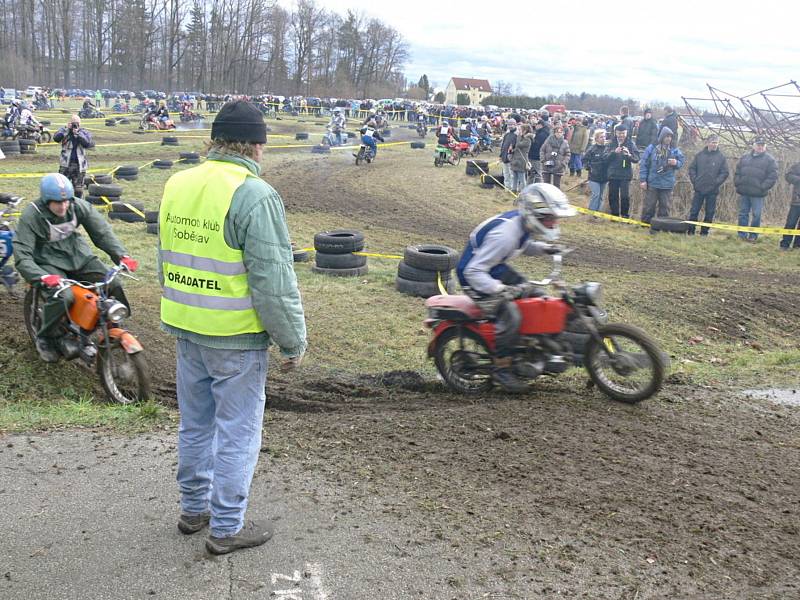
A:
[0, 102, 800, 430]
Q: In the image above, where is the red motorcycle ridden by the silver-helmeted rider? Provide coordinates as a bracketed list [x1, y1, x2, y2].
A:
[425, 254, 668, 404]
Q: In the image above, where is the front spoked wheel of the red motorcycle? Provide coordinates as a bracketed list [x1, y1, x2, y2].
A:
[584, 324, 666, 404]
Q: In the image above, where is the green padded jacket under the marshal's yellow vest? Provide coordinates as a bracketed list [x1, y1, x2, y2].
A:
[158, 152, 306, 357]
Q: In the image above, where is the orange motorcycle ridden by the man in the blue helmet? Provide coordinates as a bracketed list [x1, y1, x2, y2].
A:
[24, 265, 150, 404]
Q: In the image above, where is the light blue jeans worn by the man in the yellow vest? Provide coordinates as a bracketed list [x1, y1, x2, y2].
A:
[177, 339, 267, 537]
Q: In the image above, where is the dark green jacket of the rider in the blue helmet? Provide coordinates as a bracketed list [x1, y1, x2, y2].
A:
[14, 198, 127, 282]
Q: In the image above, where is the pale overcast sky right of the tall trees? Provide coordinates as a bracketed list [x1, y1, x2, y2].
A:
[296, 0, 800, 110]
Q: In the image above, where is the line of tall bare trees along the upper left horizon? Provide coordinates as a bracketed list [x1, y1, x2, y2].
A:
[0, 0, 408, 97]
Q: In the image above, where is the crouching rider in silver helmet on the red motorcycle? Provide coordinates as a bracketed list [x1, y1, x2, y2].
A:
[456, 183, 576, 392]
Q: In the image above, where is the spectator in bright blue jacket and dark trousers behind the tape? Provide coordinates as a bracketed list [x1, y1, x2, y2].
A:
[639, 127, 686, 223]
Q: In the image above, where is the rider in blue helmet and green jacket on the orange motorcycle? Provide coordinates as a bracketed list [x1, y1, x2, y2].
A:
[14, 173, 139, 362]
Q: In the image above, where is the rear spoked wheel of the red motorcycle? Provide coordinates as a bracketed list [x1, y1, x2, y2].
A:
[433, 327, 493, 394]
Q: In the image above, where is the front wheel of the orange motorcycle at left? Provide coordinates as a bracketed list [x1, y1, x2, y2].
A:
[97, 340, 150, 404]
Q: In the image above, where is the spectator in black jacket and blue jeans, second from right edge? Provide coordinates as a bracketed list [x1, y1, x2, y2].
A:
[733, 137, 778, 242]
